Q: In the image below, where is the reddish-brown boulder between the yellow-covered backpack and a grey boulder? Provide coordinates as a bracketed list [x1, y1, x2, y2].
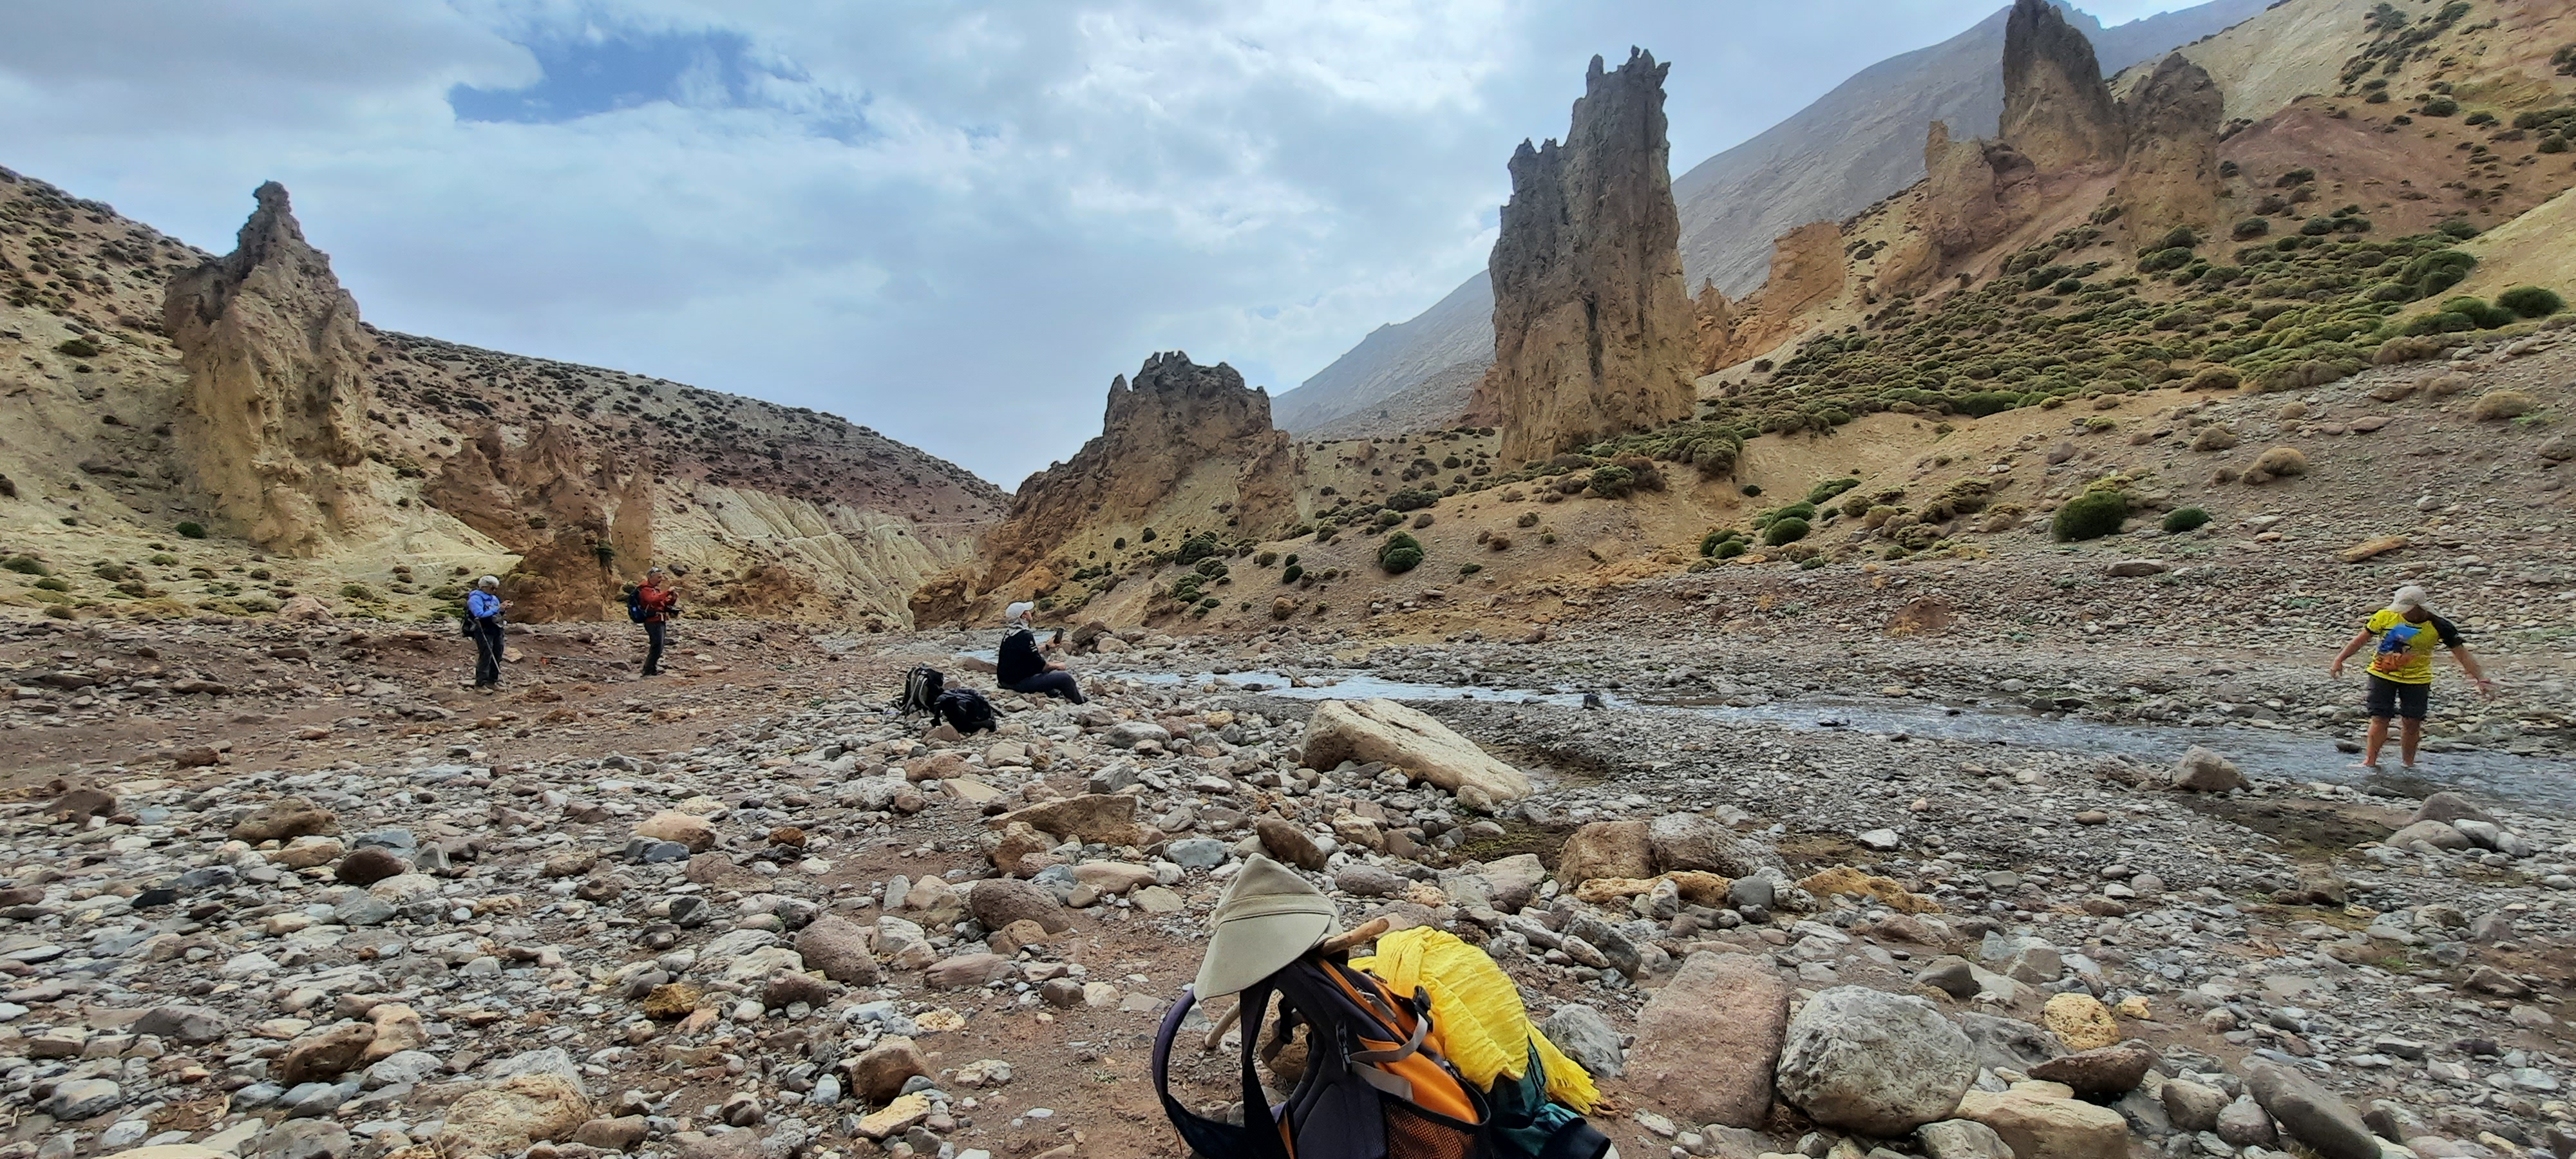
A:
[1625, 950, 1790, 1128]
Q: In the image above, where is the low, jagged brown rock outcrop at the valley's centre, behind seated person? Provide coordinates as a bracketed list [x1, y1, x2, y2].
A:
[912, 350, 1298, 623]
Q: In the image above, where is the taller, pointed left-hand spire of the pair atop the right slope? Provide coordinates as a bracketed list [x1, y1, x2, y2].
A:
[2002, 0, 2125, 173]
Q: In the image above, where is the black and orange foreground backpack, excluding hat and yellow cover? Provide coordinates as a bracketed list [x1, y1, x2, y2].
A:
[1154, 953, 1494, 1159]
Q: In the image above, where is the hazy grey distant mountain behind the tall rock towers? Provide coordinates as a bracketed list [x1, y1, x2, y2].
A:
[1278, 0, 2277, 438]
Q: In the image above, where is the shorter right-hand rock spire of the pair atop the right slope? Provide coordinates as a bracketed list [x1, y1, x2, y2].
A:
[2112, 52, 2226, 240]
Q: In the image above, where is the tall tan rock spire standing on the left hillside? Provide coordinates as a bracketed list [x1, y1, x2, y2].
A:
[162, 180, 386, 556]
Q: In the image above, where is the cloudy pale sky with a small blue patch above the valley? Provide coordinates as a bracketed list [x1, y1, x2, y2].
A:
[0, 0, 2177, 487]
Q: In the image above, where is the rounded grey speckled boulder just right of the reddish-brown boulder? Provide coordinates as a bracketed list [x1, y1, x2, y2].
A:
[1777, 986, 1978, 1138]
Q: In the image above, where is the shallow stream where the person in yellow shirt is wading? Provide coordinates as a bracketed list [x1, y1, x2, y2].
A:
[1113, 672, 2576, 816]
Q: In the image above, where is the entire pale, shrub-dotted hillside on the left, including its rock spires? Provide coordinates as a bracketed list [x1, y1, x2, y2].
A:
[0, 173, 1002, 626]
